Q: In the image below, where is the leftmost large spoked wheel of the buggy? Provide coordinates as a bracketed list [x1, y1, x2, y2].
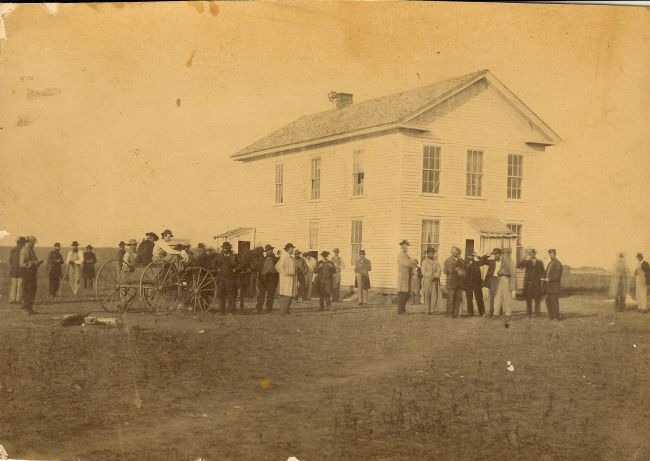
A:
[95, 259, 137, 312]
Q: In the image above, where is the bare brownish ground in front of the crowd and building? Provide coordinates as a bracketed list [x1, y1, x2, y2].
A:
[0, 297, 650, 461]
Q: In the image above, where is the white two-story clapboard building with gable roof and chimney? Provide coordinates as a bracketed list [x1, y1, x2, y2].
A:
[232, 70, 561, 289]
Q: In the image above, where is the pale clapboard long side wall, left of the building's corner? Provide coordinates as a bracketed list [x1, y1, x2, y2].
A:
[247, 133, 401, 287]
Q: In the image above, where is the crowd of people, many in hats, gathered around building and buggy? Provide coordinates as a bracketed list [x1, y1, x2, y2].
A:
[9, 229, 650, 318]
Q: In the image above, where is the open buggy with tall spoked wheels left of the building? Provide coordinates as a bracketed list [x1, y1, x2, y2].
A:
[95, 239, 217, 314]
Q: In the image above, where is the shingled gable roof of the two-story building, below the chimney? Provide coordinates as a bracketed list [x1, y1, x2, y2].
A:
[231, 69, 561, 160]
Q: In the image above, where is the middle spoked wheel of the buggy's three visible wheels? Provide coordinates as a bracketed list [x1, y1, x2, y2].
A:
[140, 261, 181, 314]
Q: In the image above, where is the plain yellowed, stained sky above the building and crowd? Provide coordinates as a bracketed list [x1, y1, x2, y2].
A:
[0, 2, 650, 267]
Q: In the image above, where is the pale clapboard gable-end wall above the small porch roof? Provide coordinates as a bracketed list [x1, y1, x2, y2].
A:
[401, 81, 545, 288]
